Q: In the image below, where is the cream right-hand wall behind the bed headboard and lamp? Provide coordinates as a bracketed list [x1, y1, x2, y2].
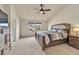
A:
[48, 5, 79, 35]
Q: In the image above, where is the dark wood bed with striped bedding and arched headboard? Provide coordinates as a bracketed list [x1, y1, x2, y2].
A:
[35, 23, 70, 50]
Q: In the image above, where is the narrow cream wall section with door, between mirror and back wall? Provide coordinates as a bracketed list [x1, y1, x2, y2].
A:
[10, 5, 20, 41]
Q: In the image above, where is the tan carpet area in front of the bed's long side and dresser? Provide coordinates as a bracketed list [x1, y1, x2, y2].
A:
[45, 44, 79, 55]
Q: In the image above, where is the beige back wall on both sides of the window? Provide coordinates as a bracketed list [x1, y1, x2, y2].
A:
[20, 19, 47, 37]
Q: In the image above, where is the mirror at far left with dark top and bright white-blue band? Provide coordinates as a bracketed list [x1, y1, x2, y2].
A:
[0, 9, 9, 33]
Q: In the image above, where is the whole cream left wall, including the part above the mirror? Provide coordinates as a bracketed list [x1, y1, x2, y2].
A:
[0, 4, 20, 41]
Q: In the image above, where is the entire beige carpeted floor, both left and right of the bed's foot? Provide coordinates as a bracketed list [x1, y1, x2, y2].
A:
[6, 37, 79, 55]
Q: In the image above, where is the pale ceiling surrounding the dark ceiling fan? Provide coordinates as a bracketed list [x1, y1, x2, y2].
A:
[14, 4, 65, 21]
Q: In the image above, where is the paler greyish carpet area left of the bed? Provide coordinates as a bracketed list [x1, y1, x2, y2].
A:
[6, 37, 45, 55]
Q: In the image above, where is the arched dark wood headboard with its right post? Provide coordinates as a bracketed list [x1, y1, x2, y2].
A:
[51, 23, 70, 39]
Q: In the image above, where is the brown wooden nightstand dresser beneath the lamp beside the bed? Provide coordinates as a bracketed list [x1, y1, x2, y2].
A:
[69, 36, 79, 49]
